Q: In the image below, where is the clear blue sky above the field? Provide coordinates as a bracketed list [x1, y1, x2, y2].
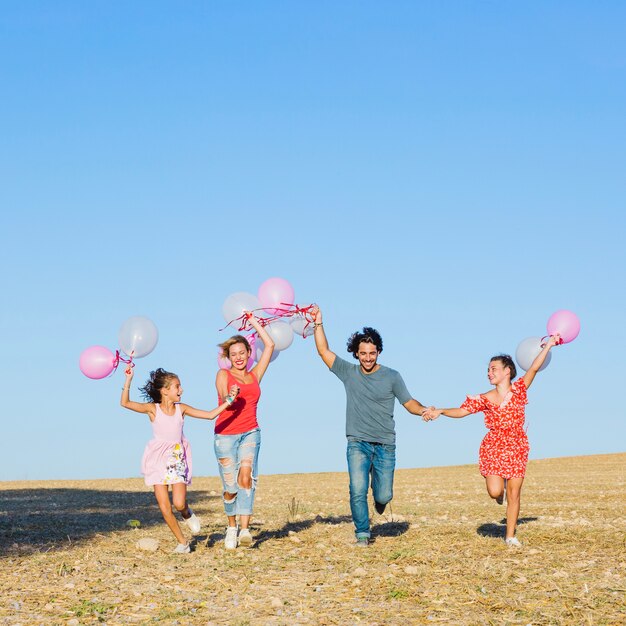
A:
[0, 1, 626, 480]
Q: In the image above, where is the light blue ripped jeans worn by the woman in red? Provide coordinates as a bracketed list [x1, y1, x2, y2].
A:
[214, 428, 261, 516]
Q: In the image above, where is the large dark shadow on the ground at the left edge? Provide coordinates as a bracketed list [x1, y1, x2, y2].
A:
[0, 489, 219, 558]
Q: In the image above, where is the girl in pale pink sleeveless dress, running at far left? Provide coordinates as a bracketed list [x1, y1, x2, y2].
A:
[120, 367, 239, 553]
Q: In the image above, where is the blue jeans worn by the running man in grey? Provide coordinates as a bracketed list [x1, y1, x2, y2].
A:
[347, 437, 396, 538]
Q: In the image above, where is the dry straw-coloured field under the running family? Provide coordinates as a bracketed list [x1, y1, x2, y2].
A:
[0, 454, 626, 626]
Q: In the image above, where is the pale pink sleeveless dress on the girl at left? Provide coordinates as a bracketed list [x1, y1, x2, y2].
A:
[141, 404, 191, 485]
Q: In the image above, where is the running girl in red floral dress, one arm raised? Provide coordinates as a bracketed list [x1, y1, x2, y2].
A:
[423, 335, 560, 546]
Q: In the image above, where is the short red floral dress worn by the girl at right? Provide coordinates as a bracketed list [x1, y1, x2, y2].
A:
[461, 378, 530, 478]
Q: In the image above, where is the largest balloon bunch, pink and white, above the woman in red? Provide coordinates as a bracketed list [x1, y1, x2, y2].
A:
[217, 277, 314, 369]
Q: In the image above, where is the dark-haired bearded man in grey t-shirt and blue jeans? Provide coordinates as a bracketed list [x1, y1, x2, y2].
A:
[312, 307, 426, 547]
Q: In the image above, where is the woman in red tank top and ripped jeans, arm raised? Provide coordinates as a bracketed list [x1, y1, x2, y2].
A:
[214, 313, 274, 550]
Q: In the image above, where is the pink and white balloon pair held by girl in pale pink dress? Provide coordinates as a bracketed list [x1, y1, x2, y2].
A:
[78, 316, 159, 379]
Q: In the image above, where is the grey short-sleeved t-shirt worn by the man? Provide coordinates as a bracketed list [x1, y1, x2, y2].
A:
[330, 356, 411, 445]
